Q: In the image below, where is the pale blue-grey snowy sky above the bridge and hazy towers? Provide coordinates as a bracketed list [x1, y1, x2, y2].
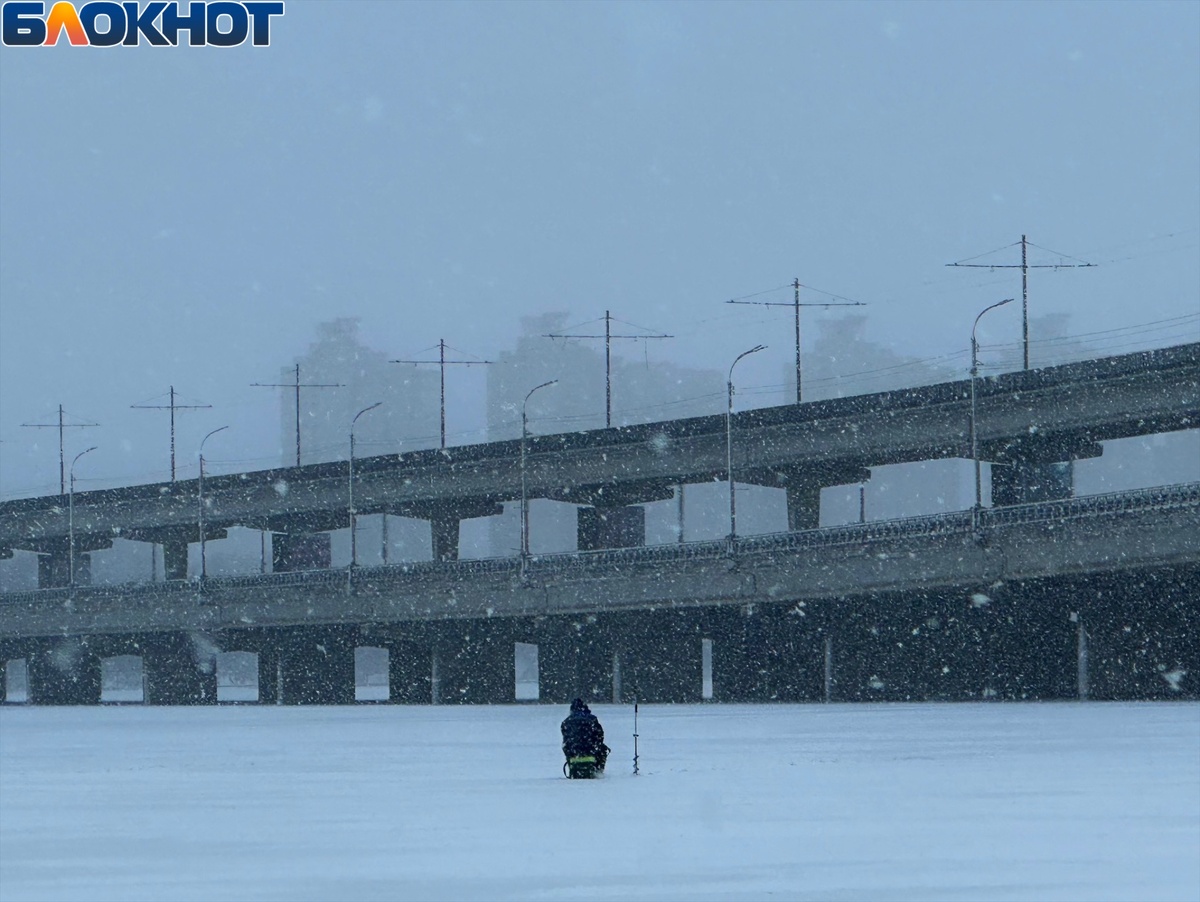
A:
[0, 0, 1200, 497]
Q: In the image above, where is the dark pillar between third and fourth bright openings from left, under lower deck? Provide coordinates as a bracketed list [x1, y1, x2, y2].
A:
[277, 626, 355, 704]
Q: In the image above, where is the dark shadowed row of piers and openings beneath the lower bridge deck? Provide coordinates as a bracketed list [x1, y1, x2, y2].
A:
[0, 564, 1200, 705]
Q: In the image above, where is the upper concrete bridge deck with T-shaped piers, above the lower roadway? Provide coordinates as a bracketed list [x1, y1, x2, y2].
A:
[0, 343, 1200, 588]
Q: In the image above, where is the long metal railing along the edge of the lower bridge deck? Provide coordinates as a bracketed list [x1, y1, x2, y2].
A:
[0, 482, 1200, 605]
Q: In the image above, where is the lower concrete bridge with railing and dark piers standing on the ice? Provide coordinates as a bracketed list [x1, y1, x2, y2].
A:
[0, 483, 1200, 704]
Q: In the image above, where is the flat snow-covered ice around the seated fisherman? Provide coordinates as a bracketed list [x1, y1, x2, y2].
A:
[0, 703, 1200, 902]
